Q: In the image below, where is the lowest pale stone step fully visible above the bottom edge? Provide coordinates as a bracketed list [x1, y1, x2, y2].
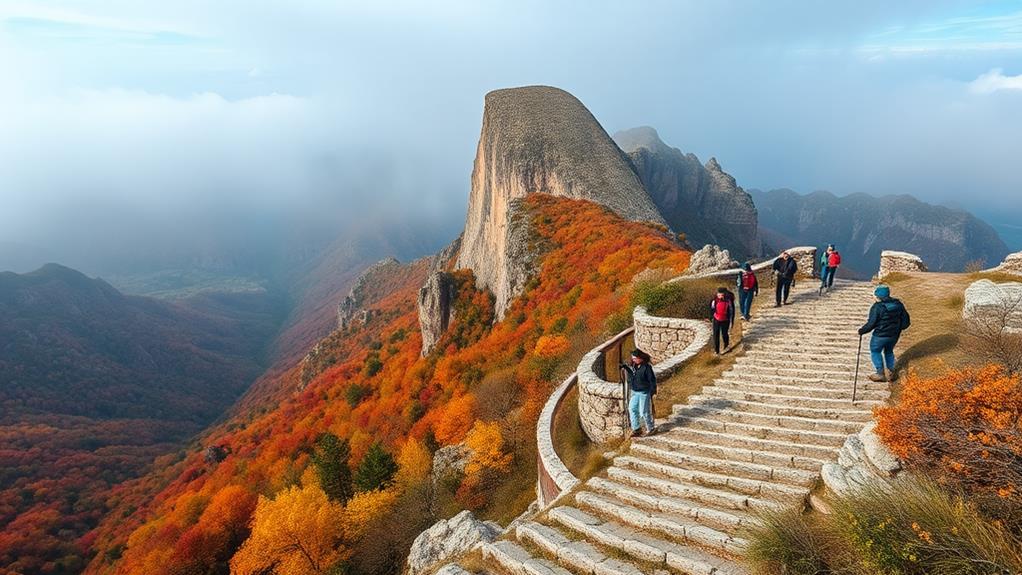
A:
[548, 506, 744, 575]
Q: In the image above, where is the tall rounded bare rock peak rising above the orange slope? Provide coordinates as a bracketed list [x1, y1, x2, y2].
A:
[457, 86, 664, 319]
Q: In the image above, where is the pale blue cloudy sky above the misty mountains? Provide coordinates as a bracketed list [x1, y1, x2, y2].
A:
[0, 0, 1022, 261]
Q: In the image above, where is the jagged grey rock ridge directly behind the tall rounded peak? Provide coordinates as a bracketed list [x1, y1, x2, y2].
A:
[614, 127, 762, 258]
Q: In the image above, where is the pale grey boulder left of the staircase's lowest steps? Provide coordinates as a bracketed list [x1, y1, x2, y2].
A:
[408, 510, 504, 575]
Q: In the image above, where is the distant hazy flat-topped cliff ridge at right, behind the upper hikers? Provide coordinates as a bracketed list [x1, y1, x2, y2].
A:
[750, 189, 1008, 277]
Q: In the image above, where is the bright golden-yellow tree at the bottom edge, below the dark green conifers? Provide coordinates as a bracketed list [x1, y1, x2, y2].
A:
[231, 485, 344, 575]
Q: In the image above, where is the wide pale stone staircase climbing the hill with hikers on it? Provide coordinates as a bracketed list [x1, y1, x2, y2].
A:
[445, 281, 889, 575]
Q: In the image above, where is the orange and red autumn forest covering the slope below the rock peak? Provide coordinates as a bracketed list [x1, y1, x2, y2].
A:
[77, 194, 689, 575]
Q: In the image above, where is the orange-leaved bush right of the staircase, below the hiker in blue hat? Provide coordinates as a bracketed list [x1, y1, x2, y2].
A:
[876, 365, 1022, 497]
